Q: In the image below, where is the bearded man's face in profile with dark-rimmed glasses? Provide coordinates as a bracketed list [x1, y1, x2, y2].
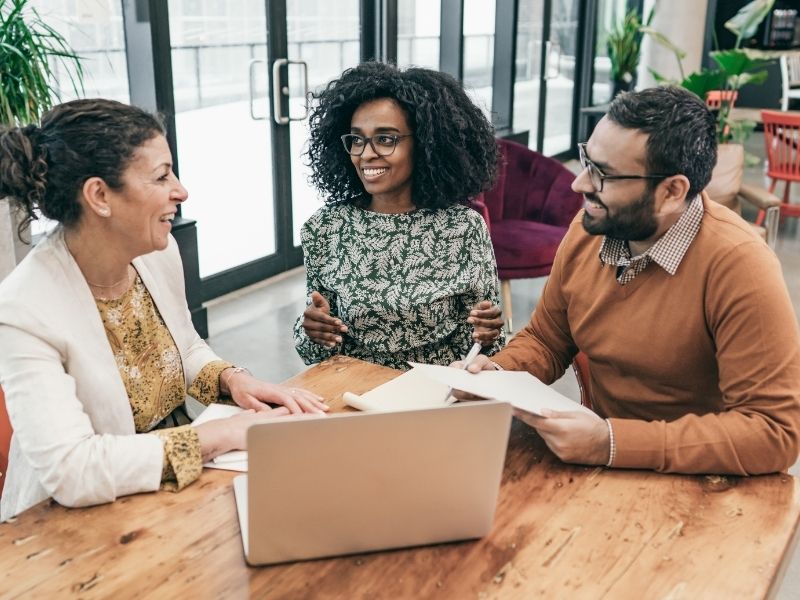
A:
[572, 118, 671, 247]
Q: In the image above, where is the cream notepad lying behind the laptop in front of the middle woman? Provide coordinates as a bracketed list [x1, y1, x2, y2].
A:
[343, 369, 447, 411]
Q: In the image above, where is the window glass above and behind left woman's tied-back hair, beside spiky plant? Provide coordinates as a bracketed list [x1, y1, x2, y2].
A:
[30, 0, 130, 235]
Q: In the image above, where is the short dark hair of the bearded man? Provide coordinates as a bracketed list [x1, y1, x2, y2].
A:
[608, 86, 717, 200]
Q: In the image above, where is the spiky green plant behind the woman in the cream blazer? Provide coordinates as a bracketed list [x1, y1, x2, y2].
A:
[0, 0, 83, 126]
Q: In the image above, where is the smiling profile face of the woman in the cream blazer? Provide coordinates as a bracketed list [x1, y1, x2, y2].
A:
[108, 135, 188, 256]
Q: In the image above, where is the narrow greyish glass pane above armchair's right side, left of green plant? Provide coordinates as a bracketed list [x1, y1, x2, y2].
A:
[542, 0, 579, 156]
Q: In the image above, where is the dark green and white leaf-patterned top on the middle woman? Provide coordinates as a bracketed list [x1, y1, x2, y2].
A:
[294, 203, 502, 369]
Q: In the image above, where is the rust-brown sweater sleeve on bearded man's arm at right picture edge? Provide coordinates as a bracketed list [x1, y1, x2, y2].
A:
[611, 241, 800, 475]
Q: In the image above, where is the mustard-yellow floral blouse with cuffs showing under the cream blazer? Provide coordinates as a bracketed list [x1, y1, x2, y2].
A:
[95, 274, 233, 491]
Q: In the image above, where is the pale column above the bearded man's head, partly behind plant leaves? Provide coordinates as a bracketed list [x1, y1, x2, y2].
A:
[636, 0, 708, 89]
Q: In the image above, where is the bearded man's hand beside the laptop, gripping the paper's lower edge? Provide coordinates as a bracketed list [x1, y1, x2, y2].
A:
[514, 409, 611, 465]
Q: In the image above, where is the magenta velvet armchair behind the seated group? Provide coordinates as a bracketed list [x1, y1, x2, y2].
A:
[473, 139, 583, 331]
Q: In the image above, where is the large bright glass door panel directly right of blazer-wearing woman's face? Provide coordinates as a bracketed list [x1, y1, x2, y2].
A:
[169, 0, 275, 277]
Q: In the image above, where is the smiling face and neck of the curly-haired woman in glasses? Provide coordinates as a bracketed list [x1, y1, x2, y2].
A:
[350, 98, 414, 212]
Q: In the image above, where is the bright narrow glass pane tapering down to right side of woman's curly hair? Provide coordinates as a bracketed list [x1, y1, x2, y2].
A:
[464, 0, 495, 120]
